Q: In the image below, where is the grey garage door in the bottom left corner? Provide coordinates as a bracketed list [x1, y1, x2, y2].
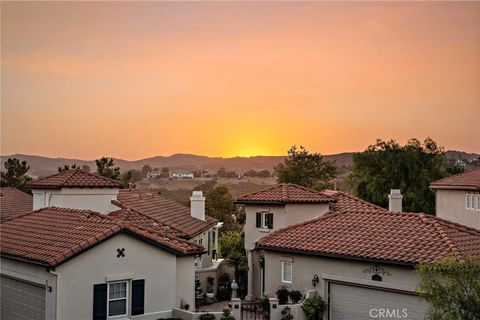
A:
[0, 276, 45, 320]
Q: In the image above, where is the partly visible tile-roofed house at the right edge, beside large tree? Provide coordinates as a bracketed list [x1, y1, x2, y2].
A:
[430, 168, 480, 230]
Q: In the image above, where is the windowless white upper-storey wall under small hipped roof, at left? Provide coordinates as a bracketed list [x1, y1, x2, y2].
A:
[32, 188, 119, 213]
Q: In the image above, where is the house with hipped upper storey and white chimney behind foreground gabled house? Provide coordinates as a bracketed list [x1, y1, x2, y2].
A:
[26, 170, 222, 267]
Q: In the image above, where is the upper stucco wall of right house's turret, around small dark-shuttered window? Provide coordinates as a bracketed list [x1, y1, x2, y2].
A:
[245, 204, 328, 250]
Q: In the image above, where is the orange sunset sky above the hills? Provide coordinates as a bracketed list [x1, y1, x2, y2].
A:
[1, 2, 480, 160]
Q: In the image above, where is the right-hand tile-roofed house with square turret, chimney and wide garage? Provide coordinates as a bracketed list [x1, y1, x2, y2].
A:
[237, 184, 480, 320]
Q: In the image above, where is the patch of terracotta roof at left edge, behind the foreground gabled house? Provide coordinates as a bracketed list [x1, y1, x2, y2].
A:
[0, 188, 33, 222]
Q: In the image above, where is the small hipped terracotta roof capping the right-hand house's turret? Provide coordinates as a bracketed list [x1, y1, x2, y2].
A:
[236, 183, 335, 204]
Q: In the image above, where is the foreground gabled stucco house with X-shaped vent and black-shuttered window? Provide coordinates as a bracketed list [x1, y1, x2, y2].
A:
[0, 207, 204, 320]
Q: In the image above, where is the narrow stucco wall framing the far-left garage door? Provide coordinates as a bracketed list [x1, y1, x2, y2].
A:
[0, 258, 57, 320]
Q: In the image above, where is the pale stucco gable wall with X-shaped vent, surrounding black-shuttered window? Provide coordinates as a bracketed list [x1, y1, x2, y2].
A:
[56, 234, 194, 320]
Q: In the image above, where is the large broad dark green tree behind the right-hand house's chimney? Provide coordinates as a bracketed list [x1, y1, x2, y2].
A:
[347, 138, 446, 213]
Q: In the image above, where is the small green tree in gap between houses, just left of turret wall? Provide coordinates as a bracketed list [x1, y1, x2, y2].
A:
[219, 231, 248, 285]
